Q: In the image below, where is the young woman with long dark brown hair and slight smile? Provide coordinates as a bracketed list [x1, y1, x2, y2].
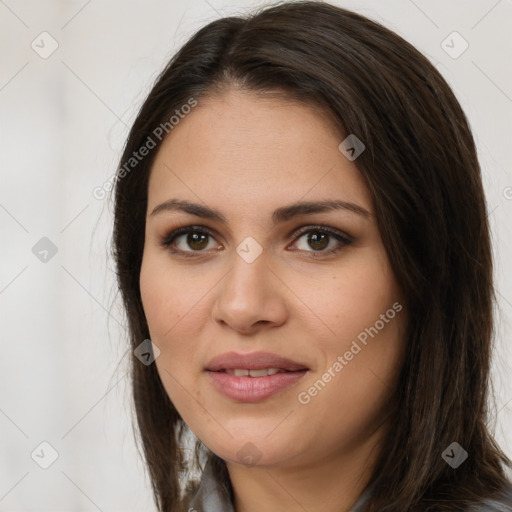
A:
[114, 2, 512, 512]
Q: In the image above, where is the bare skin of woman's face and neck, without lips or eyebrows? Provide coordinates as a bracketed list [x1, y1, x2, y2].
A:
[140, 89, 406, 512]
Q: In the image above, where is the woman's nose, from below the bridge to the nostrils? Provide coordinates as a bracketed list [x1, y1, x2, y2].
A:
[212, 251, 288, 334]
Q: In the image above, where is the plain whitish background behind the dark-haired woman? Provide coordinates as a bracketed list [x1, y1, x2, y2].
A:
[0, 0, 512, 512]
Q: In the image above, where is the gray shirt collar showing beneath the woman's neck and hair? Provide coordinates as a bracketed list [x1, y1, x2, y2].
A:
[188, 463, 512, 512]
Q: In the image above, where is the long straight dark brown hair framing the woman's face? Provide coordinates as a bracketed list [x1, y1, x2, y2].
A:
[113, 1, 511, 512]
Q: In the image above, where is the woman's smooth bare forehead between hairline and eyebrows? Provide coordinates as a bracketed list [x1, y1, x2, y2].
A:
[148, 90, 371, 210]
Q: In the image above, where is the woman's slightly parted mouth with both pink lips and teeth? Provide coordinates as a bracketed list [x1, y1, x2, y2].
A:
[205, 352, 309, 402]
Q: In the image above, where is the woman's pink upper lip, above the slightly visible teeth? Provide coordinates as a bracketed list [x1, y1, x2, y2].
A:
[206, 352, 308, 372]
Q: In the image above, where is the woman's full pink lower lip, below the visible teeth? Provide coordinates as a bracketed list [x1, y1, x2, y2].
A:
[207, 370, 307, 402]
